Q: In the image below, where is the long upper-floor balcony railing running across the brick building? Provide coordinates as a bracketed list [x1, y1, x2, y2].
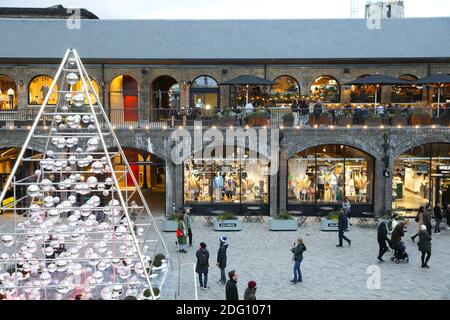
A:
[0, 107, 450, 129]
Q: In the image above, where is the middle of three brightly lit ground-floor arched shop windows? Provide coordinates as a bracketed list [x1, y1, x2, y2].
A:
[288, 145, 373, 204]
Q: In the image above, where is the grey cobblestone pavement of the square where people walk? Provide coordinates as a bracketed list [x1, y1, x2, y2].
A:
[161, 217, 450, 300]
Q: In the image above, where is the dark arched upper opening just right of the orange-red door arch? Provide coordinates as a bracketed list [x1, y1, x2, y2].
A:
[151, 76, 180, 109]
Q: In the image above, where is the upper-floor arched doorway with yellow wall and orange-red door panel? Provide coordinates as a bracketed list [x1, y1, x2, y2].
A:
[109, 75, 139, 123]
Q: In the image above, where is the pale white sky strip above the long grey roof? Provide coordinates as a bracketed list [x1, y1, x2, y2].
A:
[0, 0, 450, 19]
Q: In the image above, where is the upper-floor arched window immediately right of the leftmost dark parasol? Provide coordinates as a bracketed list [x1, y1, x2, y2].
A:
[269, 76, 300, 106]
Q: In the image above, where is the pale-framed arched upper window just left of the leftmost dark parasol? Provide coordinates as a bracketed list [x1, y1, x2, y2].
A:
[190, 76, 220, 116]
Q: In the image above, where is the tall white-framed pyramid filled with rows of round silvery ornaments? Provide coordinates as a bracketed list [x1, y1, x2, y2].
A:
[0, 49, 169, 300]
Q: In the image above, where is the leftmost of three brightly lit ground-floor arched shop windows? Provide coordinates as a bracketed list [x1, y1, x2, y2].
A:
[184, 149, 269, 204]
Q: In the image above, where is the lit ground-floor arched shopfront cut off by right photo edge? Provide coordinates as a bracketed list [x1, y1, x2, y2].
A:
[392, 143, 450, 209]
